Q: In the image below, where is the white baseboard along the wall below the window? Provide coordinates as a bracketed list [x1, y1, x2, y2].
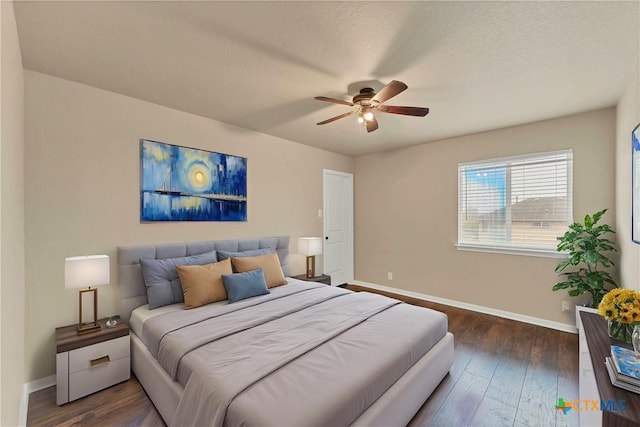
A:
[349, 280, 578, 334]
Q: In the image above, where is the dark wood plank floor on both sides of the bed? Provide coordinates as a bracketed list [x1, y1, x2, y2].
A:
[27, 285, 578, 427]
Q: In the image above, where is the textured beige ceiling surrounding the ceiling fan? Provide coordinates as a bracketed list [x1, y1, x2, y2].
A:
[15, 1, 640, 156]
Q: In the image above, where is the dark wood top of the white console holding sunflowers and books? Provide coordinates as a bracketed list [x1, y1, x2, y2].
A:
[580, 312, 640, 427]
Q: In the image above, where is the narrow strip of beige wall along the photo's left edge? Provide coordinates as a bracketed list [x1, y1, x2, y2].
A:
[0, 1, 25, 426]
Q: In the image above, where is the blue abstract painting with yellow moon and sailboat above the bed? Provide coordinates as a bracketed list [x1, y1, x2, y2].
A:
[140, 139, 247, 222]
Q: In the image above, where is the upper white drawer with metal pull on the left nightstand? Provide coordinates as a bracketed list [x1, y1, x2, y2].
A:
[69, 335, 131, 374]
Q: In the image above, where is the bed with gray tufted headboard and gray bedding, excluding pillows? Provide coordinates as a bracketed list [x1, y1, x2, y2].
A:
[118, 236, 453, 426]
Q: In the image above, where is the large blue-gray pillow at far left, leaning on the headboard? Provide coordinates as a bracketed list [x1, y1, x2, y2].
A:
[140, 251, 217, 310]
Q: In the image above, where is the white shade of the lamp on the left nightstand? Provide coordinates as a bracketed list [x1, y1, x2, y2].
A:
[64, 255, 110, 288]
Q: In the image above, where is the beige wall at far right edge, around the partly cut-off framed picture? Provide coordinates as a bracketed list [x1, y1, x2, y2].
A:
[616, 61, 640, 289]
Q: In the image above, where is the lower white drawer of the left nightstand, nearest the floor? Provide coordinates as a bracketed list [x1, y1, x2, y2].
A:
[69, 356, 131, 401]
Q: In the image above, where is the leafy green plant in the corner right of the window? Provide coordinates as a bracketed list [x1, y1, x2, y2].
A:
[553, 209, 618, 308]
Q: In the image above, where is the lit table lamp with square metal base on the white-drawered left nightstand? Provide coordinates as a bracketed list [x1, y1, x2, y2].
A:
[64, 255, 110, 335]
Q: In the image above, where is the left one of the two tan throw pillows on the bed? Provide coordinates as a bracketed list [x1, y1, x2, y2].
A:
[176, 259, 233, 309]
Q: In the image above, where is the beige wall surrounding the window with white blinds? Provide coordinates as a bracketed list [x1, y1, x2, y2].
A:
[355, 109, 616, 324]
